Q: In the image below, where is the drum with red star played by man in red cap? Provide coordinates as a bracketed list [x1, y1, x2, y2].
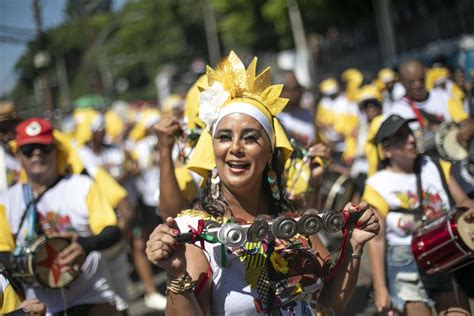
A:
[12, 236, 79, 288]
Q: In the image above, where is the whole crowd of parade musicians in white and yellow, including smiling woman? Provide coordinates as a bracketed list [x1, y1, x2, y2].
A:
[0, 52, 474, 315]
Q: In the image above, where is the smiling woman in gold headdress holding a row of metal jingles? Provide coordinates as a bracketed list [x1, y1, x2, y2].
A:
[146, 52, 379, 315]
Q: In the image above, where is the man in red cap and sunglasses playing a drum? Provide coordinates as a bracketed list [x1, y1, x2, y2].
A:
[0, 118, 125, 315]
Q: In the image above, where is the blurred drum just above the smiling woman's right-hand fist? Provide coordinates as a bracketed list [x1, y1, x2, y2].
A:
[321, 172, 355, 211]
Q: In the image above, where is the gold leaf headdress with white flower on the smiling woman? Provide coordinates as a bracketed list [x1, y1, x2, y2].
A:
[188, 51, 292, 181]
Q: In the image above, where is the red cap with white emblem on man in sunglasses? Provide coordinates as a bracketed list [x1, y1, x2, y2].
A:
[16, 117, 53, 146]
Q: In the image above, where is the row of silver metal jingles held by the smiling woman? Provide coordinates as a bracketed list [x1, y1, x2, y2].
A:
[176, 209, 363, 248]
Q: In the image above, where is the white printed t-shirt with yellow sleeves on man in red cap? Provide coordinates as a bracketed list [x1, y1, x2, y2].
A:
[0, 175, 119, 313]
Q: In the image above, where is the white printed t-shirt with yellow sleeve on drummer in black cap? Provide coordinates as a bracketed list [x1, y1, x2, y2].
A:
[363, 156, 449, 245]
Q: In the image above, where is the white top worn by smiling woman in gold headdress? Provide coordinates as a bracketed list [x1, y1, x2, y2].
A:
[176, 215, 323, 316]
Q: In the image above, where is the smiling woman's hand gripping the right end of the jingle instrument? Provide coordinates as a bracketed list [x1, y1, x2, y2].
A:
[344, 202, 380, 251]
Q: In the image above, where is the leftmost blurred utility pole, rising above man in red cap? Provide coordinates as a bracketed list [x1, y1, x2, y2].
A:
[33, 0, 54, 115]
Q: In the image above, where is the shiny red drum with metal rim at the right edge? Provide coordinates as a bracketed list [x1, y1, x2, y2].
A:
[411, 208, 474, 274]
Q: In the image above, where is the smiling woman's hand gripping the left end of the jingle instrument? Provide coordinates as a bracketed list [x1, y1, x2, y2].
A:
[146, 217, 186, 277]
